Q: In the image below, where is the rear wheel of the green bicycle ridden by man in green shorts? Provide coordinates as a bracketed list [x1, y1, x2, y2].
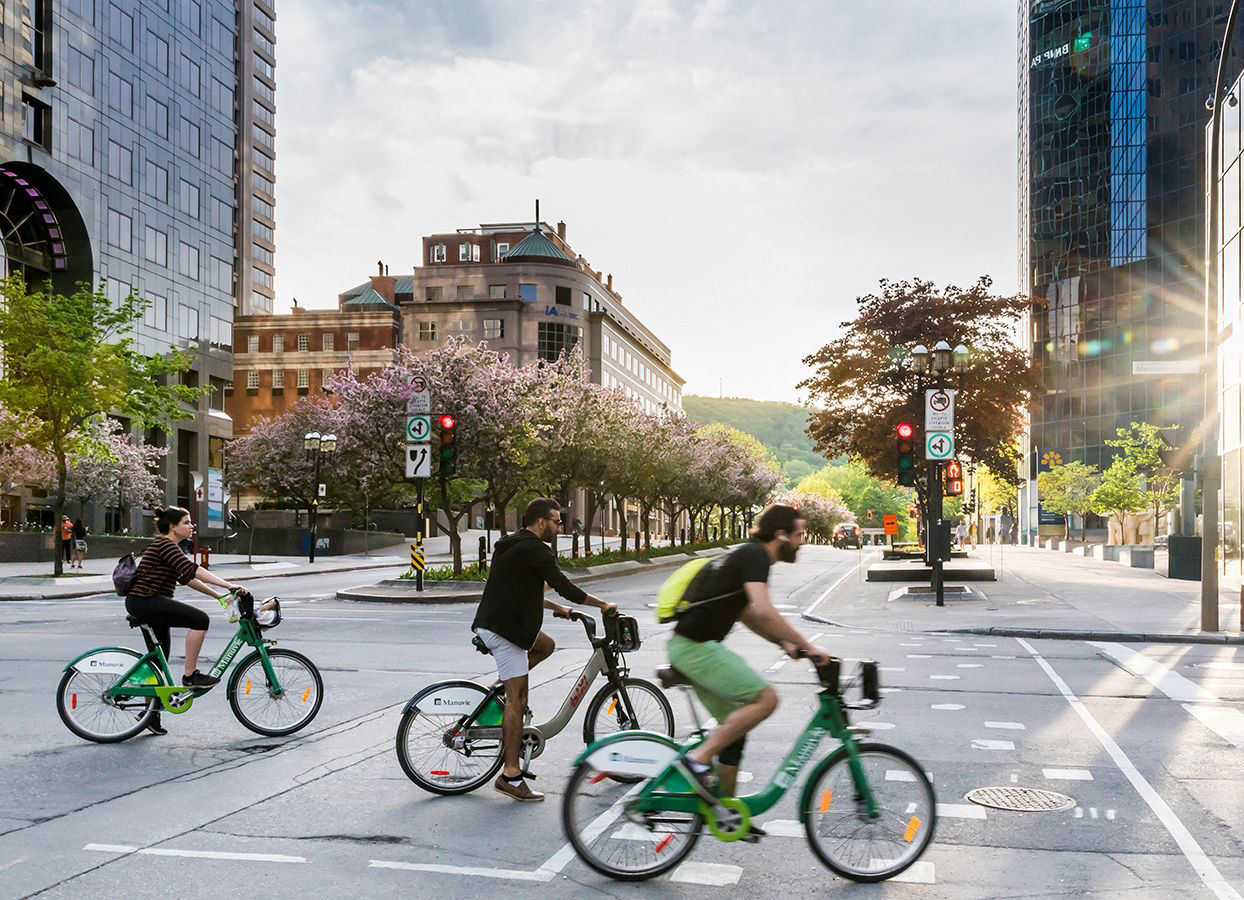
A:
[561, 737, 704, 881]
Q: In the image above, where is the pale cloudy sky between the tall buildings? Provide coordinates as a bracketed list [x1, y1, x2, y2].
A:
[276, 0, 1016, 400]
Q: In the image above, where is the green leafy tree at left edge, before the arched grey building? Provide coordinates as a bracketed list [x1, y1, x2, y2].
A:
[0, 275, 199, 575]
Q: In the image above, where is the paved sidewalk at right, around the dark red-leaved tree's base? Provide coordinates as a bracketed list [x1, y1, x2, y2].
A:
[805, 546, 1244, 644]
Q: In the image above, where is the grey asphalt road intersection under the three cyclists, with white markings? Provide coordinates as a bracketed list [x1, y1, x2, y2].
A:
[0, 548, 1244, 898]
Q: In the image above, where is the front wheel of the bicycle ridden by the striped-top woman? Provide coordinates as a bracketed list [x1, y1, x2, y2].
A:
[229, 650, 323, 737]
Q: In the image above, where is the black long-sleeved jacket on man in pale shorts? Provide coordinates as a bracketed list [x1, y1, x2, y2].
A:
[471, 528, 587, 650]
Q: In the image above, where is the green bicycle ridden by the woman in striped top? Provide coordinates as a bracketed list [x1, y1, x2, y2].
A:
[56, 593, 323, 743]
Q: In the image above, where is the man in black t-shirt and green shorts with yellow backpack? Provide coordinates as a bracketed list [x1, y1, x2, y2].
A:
[668, 504, 830, 821]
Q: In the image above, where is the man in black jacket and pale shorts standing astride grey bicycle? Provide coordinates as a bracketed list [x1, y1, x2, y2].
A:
[471, 498, 617, 802]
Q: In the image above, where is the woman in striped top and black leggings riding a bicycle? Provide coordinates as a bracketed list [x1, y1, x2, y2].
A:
[126, 507, 249, 734]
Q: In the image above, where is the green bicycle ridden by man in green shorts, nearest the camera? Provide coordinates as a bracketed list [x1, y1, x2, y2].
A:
[561, 659, 937, 881]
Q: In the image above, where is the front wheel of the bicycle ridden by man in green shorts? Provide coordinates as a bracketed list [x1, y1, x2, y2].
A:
[801, 743, 937, 881]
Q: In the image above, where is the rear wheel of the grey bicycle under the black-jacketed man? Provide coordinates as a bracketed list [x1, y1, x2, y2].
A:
[397, 681, 503, 794]
